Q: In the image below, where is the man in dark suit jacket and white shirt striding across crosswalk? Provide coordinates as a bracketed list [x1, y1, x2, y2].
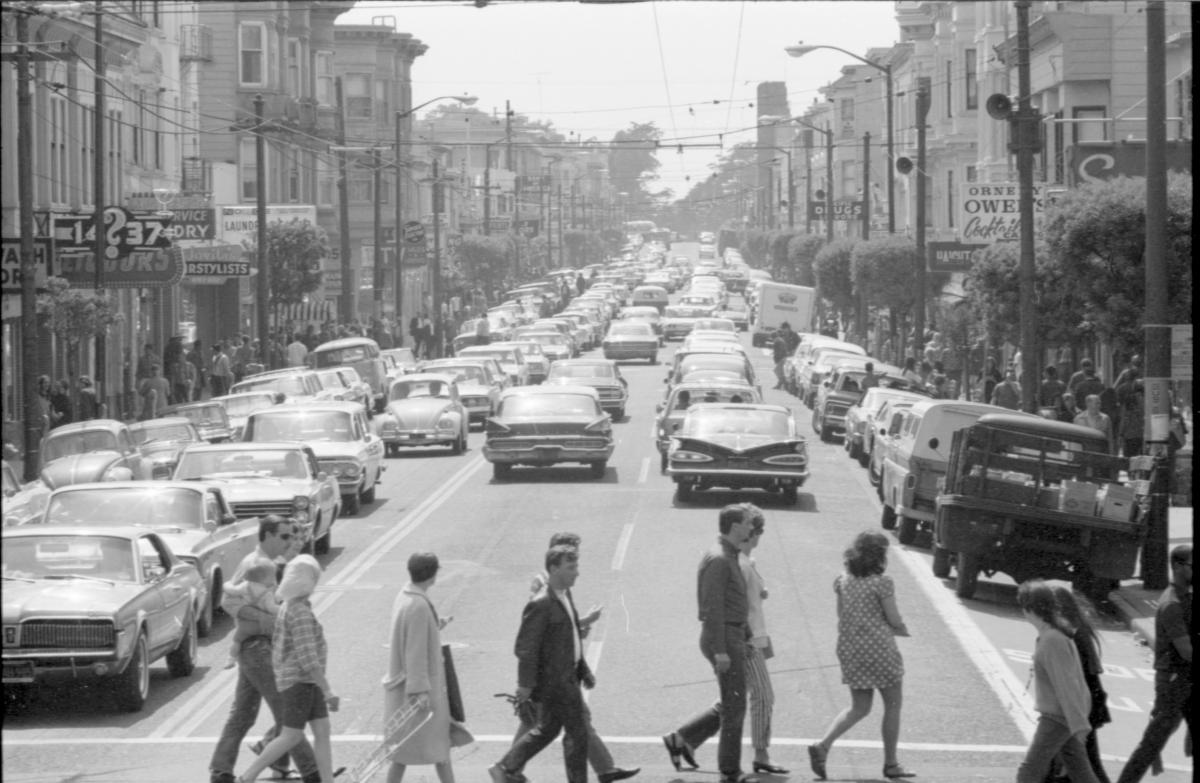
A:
[487, 545, 595, 783]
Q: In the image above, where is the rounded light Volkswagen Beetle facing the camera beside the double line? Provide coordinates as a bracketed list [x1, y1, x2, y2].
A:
[379, 370, 470, 456]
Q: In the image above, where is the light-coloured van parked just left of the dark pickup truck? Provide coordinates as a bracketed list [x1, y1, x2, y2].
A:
[880, 400, 1027, 544]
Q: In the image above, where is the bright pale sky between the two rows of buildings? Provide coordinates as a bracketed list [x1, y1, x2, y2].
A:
[337, 0, 900, 198]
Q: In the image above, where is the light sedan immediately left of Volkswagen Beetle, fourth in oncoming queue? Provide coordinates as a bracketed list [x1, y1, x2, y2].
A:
[242, 402, 384, 514]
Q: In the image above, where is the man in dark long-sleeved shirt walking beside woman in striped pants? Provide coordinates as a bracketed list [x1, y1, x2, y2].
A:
[662, 503, 757, 783]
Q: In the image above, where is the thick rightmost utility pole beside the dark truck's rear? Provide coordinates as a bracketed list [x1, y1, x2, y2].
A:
[1141, 0, 1175, 590]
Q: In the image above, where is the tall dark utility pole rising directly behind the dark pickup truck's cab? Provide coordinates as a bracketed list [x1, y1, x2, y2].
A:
[1017, 0, 1039, 413]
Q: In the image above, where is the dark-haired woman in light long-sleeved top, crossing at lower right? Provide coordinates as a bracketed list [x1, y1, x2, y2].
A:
[1016, 579, 1099, 783]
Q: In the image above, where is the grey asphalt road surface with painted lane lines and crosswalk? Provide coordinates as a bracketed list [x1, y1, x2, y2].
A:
[2, 245, 1192, 783]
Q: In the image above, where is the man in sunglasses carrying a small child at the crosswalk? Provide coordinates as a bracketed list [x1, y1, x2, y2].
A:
[209, 514, 320, 783]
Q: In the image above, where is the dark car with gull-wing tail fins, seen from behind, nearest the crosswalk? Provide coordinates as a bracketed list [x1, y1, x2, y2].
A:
[666, 402, 809, 504]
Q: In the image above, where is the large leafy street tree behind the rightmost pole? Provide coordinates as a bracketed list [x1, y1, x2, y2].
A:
[1043, 172, 1193, 351]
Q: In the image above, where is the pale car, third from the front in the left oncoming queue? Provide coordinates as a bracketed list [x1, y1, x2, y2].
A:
[172, 443, 342, 555]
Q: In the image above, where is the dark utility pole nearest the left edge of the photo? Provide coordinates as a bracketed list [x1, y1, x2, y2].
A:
[16, 8, 40, 482]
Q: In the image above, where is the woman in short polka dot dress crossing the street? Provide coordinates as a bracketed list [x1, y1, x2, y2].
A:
[809, 531, 914, 781]
